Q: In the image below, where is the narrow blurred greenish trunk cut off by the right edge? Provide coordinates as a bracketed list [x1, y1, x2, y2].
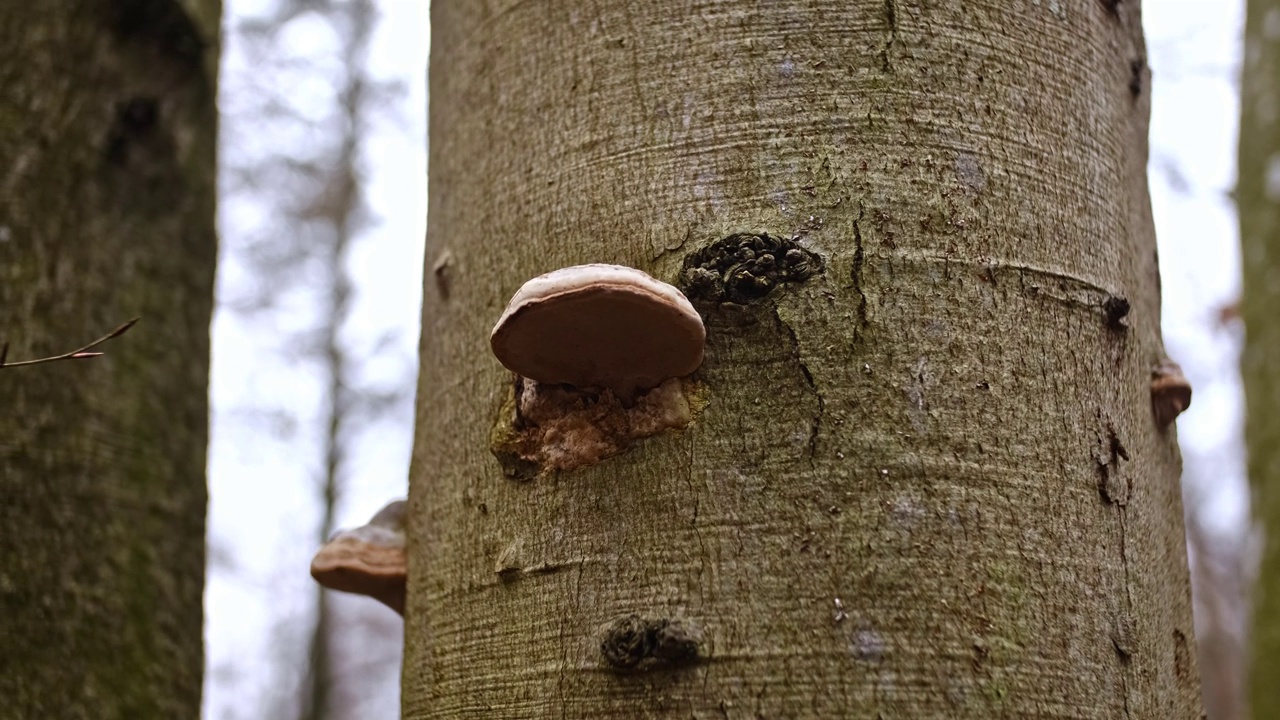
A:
[1236, 0, 1280, 720]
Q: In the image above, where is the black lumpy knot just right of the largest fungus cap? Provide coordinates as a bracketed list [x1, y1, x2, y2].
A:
[680, 233, 823, 305]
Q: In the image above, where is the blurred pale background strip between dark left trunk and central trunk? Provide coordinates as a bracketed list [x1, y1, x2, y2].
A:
[204, 0, 419, 720]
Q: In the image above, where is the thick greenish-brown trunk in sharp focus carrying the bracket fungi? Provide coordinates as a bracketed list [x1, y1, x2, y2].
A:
[403, 0, 1199, 719]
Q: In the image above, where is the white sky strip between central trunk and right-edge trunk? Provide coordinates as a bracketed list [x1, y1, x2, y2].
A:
[1143, 0, 1248, 534]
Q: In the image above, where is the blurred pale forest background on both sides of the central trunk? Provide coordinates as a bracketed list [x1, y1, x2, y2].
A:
[204, 0, 1252, 720]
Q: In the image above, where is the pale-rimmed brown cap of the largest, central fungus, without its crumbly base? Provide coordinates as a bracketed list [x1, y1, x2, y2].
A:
[489, 264, 707, 402]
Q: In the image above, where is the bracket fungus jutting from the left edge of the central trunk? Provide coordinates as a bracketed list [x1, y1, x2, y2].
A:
[311, 500, 408, 615]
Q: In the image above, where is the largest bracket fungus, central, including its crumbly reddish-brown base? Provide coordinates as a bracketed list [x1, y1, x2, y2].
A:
[489, 264, 707, 477]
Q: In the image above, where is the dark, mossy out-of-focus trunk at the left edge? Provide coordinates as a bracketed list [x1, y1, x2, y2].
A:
[0, 0, 220, 720]
